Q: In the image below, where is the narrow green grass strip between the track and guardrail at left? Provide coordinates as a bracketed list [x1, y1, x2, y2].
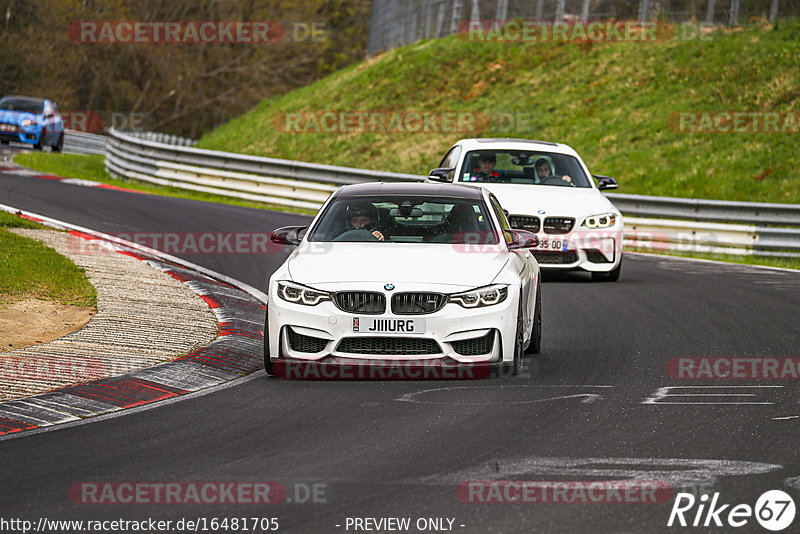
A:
[14, 152, 315, 215]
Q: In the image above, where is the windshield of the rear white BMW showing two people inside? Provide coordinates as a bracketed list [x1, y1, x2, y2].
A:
[458, 150, 591, 188]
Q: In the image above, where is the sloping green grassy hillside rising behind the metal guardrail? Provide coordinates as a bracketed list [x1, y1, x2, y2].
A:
[198, 22, 800, 203]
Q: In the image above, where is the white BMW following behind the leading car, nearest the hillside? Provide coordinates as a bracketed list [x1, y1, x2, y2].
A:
[428, 139, 623, 281]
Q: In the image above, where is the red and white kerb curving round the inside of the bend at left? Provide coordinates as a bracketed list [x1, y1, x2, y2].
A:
[0, 204, 266, 440]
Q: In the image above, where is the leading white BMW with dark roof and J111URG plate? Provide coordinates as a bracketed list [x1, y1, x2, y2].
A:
[264, 183, 542, 379]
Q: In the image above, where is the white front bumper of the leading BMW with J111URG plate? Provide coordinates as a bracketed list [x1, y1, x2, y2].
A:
[267, 281, 519, 378]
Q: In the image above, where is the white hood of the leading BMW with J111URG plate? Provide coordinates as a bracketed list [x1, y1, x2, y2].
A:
[287, 242, 508, 289]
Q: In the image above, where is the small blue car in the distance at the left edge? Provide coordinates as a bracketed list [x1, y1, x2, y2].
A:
[0, 96, 64, 152]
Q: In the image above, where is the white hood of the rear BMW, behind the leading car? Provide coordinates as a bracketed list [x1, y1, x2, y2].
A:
[484, 184, 619, 217]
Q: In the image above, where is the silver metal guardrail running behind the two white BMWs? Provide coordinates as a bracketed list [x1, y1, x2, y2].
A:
[105, 128, 800, 257]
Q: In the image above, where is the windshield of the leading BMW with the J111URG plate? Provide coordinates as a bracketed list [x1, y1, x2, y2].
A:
[308, 196, 498, 245]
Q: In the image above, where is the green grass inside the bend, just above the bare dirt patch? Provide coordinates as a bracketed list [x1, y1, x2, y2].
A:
[0, 212, 97, 307]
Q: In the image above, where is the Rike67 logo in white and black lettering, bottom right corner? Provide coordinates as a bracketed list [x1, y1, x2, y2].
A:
[667, 490, 796, 532]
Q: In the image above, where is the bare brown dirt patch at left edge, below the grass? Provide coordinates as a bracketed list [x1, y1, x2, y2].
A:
[0, 299, 97, 352]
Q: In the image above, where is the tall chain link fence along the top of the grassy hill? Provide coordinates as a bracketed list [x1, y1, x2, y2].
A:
[367, 0, 800, 55]
